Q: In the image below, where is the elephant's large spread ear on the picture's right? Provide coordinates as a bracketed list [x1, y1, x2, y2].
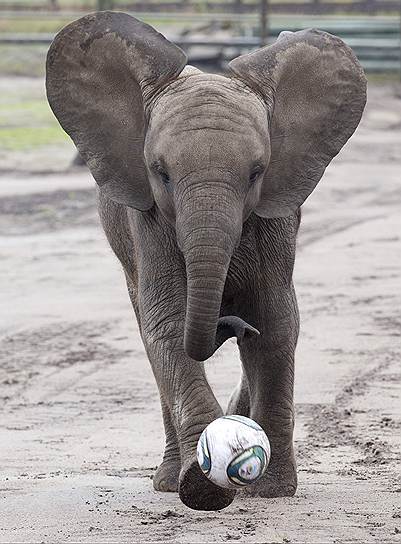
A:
[230, 30, 366, 217]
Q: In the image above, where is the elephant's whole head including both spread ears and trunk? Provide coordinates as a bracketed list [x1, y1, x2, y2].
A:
[47, 12, 366, 360]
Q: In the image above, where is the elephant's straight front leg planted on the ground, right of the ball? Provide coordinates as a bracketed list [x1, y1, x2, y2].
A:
[240, 287, 299, 497]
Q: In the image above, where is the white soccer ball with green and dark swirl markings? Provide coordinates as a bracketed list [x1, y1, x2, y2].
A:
[196, 415, 270, 489]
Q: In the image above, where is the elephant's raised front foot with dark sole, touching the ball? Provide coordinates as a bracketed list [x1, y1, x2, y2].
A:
[178, 459, 235, 510]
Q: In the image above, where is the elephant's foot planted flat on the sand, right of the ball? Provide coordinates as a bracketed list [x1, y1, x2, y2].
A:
[244, 463, 297, 498]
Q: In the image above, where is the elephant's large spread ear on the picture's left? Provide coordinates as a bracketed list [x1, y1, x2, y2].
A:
[46, 12, 186, 210]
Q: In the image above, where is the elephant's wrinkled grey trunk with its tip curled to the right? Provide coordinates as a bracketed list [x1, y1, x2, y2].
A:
[177, 181, 257, 361]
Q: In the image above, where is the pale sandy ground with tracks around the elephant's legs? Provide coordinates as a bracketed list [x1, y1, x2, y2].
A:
[0, 83, 401, 543]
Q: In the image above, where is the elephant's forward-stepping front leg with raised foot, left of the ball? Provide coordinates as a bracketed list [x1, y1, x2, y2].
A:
[138, 242, 234, 510]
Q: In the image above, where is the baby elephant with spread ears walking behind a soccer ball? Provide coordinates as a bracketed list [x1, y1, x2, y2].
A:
[47, 12, 366, 510]
